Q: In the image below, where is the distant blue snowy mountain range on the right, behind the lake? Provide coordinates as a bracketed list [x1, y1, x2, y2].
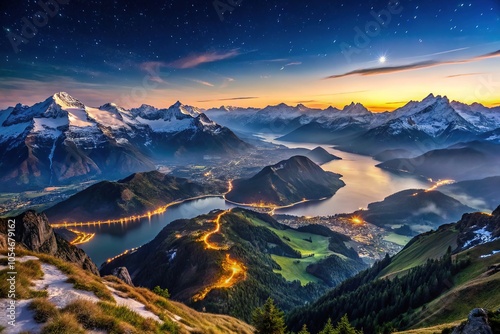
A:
[206, 94, 500, 154]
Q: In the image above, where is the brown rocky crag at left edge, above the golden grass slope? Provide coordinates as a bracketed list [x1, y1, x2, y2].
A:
[0, 211, 99, 275]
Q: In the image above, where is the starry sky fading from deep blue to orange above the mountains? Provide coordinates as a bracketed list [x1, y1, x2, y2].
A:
[0, 0, 500, 111]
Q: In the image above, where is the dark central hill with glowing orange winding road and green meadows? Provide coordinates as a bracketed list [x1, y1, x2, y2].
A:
[101, 209, 365, 320]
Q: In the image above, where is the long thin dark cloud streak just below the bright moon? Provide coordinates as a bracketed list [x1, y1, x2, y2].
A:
[325, 50, 500, 79]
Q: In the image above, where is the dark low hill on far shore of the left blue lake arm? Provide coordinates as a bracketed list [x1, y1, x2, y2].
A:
[45, 171, 224, 223]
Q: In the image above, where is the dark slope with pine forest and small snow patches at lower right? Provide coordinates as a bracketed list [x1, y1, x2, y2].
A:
[288, 207, 500, 333]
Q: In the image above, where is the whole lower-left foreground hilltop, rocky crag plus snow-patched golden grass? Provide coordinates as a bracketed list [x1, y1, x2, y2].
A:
[0, 211, 254, 334]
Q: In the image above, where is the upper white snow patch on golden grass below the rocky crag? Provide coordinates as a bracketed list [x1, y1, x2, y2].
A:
[33, 263, 99, 308]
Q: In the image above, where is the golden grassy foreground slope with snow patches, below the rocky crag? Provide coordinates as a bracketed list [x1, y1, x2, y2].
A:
[0, 250, 254, 334]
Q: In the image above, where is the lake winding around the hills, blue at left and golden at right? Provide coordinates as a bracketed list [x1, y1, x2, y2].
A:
[69, 138, 430, 266]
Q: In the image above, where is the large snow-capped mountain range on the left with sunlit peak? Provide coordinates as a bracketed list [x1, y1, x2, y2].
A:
[0, 92, 249, 189]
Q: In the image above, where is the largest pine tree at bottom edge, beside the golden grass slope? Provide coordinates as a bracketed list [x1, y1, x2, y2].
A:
[252, 298, 286, 334]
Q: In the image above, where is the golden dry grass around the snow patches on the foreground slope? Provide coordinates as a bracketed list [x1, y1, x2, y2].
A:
[0, 249, 254, 334]
